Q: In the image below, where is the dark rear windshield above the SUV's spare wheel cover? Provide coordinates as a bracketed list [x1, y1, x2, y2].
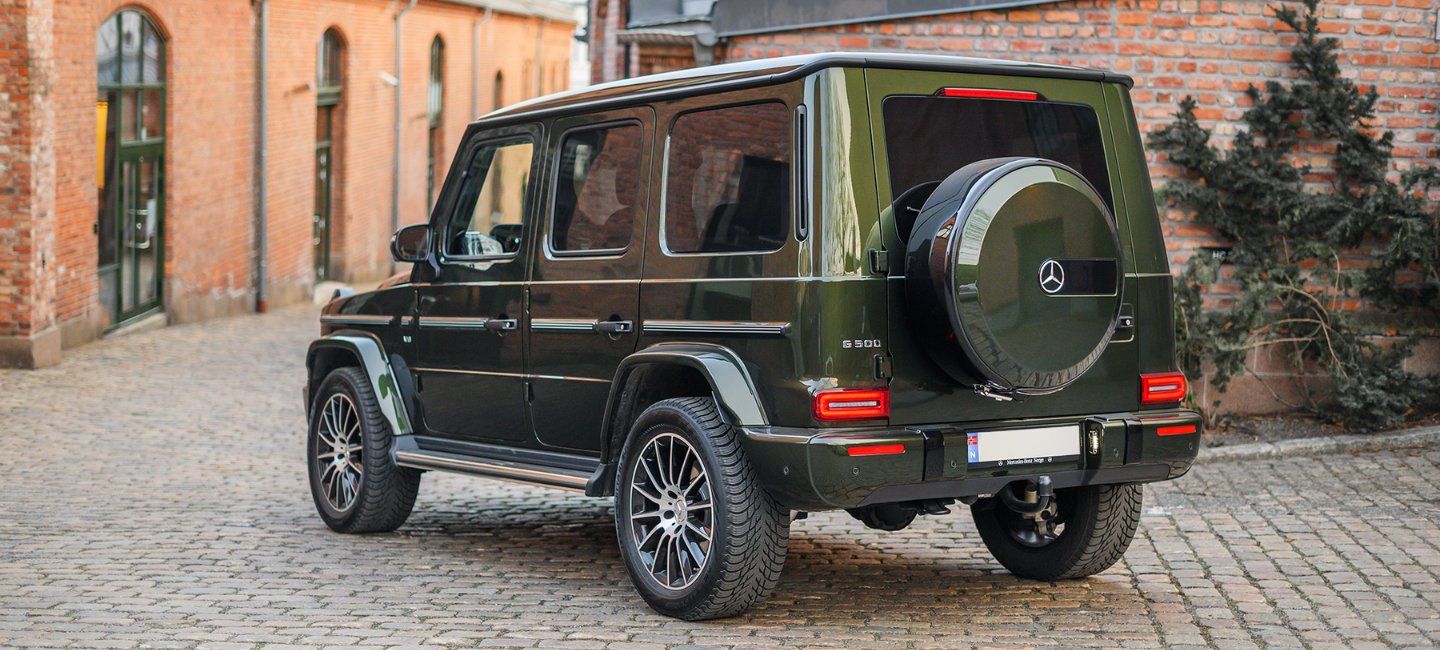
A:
[883, 97, 1115, 209]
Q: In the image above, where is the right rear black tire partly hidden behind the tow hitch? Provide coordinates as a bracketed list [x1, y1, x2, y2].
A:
[971, 483, 1142, 582]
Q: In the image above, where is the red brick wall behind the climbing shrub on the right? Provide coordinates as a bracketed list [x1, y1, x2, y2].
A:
[721, 0, 1440, 278]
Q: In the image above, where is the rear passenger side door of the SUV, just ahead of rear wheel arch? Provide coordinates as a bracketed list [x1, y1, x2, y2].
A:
[528, 107, 655, 451]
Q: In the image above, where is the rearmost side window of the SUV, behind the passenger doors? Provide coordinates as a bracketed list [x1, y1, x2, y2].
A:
[665, 102, 791, 252]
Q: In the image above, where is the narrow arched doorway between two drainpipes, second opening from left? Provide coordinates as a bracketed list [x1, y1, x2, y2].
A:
[311, 27, 346, 282]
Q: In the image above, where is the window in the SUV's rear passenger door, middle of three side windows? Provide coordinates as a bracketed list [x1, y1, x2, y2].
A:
[550, 124, 644, 254]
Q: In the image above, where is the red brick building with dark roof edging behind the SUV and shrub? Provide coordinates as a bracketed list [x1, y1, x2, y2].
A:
[590, 0, 1440, 412]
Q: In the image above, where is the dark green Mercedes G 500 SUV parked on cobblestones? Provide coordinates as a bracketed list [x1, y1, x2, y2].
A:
[307, 53, 1201, 620]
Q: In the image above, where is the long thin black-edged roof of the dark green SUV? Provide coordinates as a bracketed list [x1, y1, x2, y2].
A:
[471, 52, 1135, 127]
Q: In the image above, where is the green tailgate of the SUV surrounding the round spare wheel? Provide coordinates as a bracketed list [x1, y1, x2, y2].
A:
[865, 69, 1138, 424]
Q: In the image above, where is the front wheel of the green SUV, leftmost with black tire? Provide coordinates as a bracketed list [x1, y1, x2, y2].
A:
[305, 368, 420, 533]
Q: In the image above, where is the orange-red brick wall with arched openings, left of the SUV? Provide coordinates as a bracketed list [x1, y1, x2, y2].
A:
[0, 0, 575, 366]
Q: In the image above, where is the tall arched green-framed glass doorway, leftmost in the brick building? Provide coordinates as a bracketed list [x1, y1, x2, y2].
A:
[95, 9, 166, 327]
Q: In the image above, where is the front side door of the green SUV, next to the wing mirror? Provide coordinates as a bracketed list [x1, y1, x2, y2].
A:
[415, 125, 543, 442]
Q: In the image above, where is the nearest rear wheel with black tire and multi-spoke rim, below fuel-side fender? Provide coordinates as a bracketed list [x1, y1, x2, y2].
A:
[615, 398, 791, 621]
